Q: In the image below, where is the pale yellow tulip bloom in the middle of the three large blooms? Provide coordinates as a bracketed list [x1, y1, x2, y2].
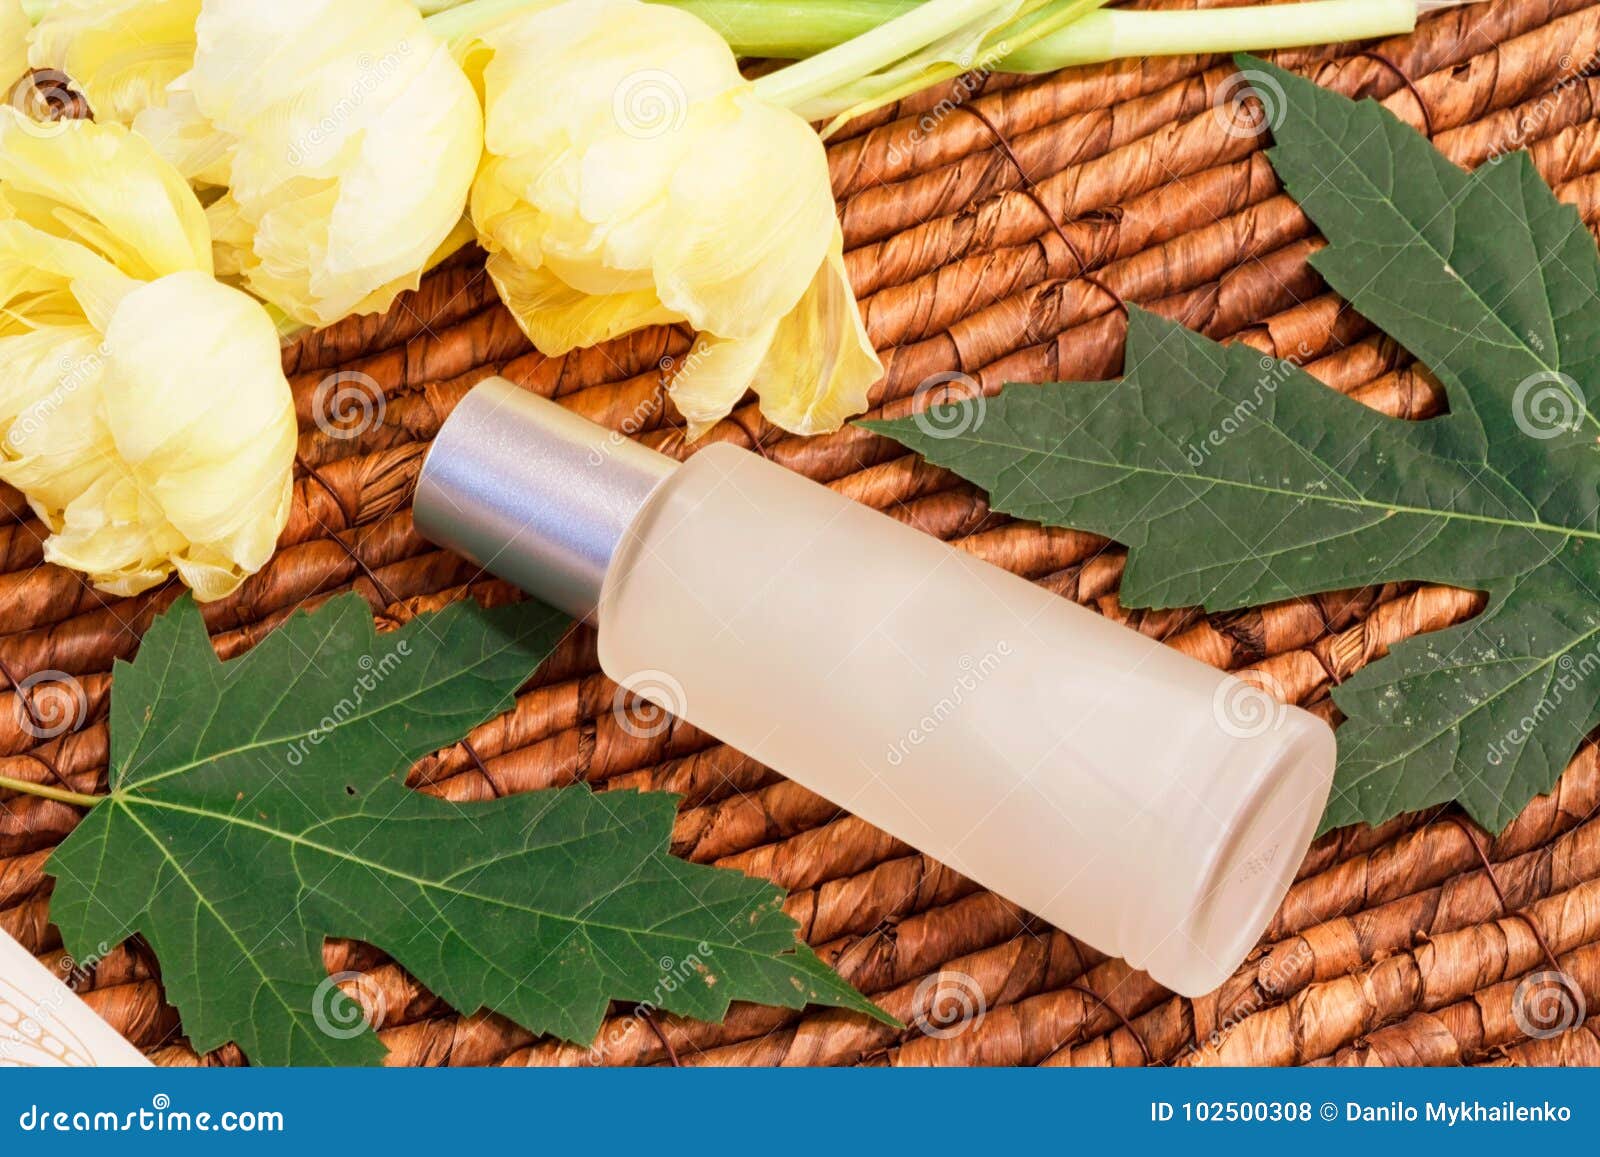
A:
[30, 0, 482, 325]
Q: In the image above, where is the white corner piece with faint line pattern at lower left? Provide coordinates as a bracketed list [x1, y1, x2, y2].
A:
[0, 931, 149, 1069]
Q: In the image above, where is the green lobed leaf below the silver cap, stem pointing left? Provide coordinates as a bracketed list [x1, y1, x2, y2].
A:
[48, 595, 882, 1064]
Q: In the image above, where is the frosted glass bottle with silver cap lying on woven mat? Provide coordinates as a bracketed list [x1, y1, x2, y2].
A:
[414, 379, 1334, 995]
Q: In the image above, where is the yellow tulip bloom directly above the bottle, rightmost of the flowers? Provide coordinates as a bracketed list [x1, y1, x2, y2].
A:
[462, 0, 882, 437]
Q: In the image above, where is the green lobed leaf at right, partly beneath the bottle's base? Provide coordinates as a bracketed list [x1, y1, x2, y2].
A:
[869, 58, 1600, 831]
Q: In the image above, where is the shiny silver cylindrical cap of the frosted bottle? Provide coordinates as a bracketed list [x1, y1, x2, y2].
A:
[413, 378, 677, 618]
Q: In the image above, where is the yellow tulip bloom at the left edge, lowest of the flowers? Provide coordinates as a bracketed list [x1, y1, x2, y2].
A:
[0, 109, 296, 600]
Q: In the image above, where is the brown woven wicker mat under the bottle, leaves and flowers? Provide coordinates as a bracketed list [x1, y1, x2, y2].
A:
[0, 0, 1600, 1064]
